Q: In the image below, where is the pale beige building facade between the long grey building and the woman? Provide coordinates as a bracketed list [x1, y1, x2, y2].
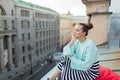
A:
[60, 16, 73, 51]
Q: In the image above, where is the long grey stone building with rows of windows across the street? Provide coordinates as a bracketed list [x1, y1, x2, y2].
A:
[0, 0, 59, 80]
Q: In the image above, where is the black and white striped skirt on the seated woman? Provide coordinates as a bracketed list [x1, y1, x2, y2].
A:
[57, 57, 99, 80]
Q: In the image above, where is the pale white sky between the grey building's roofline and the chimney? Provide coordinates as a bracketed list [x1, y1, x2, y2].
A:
[23, 0, 86, 16]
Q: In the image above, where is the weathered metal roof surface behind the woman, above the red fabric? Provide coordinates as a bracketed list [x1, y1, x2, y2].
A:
[99, 48, 120, 75]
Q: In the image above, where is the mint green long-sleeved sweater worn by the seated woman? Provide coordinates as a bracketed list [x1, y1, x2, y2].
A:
[63, 38, 98, 71]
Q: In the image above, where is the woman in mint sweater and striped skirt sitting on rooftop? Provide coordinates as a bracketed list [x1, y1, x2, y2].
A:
[49, 23, 99, 80]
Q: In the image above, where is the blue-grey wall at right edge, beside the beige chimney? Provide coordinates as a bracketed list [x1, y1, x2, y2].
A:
[108, 13, 120, 49]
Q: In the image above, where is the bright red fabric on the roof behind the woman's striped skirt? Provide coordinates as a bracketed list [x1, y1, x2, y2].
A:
[96, 66, 120, 80]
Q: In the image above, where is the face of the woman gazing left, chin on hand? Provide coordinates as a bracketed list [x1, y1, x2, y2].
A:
[73, 24, 85, 39]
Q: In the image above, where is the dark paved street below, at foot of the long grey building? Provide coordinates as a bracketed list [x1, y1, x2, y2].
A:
[13, 62, 56, 80]
